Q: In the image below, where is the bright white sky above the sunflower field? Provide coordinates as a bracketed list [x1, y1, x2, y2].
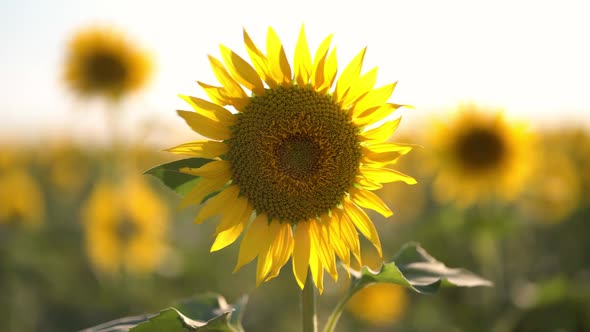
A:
[0, 0, 590, 144]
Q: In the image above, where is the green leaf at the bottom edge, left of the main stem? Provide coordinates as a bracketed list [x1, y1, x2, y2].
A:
[83, 293, 247, 332]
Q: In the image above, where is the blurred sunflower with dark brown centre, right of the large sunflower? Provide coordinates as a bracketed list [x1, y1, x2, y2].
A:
[428, 105, 533, 206]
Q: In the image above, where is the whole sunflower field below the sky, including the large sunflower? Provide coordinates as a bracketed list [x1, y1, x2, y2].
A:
[0, 3, 590, 332]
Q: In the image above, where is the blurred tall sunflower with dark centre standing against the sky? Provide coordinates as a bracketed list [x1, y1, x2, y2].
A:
[64, 27, 152, 100]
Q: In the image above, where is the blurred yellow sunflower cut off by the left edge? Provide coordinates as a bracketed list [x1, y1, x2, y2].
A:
[0, 147, 45, 227]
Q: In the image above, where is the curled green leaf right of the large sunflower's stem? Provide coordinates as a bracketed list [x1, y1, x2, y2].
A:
[353, 243, 493, 294]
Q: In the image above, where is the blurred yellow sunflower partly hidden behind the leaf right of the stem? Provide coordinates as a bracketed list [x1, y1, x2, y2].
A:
[346, 250, 409, 326]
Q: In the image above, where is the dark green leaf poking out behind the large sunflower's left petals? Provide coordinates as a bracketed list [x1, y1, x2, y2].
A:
[145, 158, 213, 196]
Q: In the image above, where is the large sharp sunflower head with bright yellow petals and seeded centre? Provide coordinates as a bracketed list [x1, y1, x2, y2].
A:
[169, 27, 415, 292]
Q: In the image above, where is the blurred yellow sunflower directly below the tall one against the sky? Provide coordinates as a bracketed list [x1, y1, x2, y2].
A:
[83, 176, 168, 275]
